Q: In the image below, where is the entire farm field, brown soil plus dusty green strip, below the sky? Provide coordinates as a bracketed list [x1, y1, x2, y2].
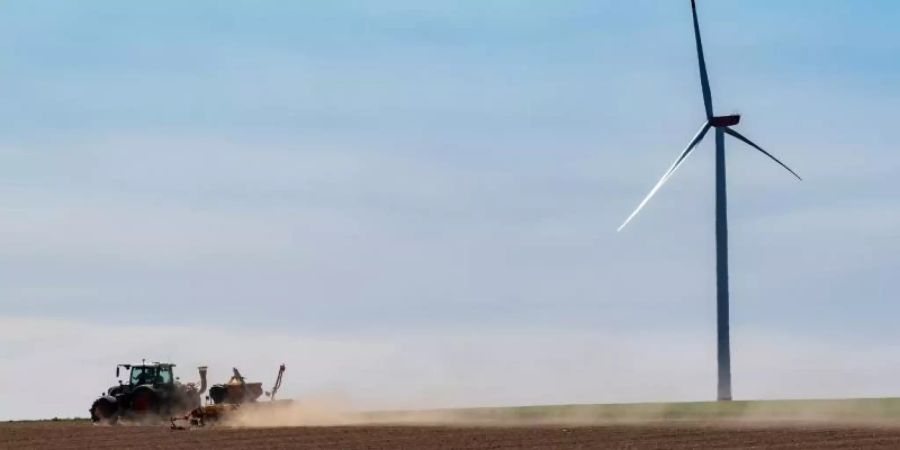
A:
[7, 398, 900, 449]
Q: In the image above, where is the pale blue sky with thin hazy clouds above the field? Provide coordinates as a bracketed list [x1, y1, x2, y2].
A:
[0, 0, 900, 419]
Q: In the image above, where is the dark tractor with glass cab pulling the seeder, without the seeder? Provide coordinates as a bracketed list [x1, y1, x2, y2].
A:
[90, 362, 206, 425]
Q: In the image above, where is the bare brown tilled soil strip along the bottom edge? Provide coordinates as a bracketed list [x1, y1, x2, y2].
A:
[0, 422, 900, 449]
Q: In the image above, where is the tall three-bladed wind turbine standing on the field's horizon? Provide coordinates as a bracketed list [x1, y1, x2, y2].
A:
[619, 0, 801, 401]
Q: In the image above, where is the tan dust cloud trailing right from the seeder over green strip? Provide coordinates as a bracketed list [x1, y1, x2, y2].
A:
[223, 398, 900, 427]
